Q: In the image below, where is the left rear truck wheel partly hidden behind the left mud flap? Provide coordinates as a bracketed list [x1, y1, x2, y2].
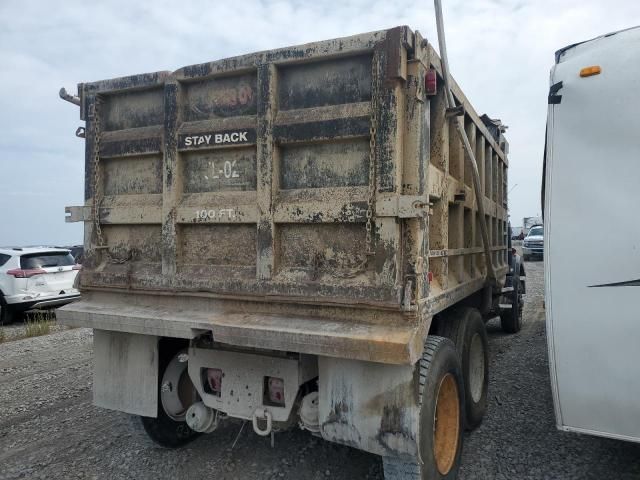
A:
[140, 350, 199, 448]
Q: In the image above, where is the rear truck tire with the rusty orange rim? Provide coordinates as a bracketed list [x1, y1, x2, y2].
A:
[382, 335, 464, 480]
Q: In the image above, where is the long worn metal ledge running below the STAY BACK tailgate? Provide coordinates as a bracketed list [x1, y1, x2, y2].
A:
[56, 292, 429, 365]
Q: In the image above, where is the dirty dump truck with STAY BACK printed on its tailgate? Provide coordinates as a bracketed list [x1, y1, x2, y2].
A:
[58, 26, 524, 479]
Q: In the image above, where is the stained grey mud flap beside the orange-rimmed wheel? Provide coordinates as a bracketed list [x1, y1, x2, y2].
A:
[318, 357, 420, 459]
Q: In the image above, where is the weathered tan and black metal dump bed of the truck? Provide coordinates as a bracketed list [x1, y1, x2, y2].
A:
[61, 27, 507, 363]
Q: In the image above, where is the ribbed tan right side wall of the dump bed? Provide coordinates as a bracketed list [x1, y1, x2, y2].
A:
[404, 33, 509, 317]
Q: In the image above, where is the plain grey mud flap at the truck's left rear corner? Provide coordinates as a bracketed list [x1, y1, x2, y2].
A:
[93, 330, 158, 417]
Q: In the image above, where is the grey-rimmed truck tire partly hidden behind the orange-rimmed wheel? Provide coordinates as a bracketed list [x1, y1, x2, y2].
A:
[438, 307, 489, 430]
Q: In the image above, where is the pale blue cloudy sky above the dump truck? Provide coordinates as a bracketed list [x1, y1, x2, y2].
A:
[0, 0, 640, 245]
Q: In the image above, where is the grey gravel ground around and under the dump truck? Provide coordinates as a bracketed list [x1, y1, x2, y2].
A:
[0, 262, 640, 480]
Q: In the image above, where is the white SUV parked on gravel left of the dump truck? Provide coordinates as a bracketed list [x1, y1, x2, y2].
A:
[0, 247, 80, 325]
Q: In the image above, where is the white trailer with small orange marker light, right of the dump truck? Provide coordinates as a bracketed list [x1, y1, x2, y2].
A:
[543, 28, 640, 442]
